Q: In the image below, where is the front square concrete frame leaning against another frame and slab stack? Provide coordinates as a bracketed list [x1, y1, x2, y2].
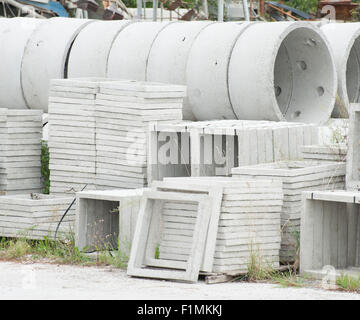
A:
[127, 191, 211, 282]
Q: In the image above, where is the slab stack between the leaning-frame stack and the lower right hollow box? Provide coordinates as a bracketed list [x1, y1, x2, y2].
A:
[232, 161, 346, 263]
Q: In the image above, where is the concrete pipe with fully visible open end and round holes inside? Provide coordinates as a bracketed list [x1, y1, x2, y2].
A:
[229, 22, 337, 124]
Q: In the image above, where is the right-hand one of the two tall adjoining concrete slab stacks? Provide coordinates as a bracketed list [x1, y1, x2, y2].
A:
[95, 81, 186, 189]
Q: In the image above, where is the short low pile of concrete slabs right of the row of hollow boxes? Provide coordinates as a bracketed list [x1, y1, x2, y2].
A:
[301, 144, 347, 162]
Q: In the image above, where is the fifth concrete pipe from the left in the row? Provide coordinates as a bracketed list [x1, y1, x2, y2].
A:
[146, 21, 213, 120]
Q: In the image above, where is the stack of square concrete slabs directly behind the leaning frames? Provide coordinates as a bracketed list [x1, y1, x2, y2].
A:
[153, 177, 283, 273]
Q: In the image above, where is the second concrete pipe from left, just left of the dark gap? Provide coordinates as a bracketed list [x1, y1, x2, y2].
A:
[21, 18, 93, 112]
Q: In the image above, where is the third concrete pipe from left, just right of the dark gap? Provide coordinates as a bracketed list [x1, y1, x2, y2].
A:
[68, 20, 132, 78]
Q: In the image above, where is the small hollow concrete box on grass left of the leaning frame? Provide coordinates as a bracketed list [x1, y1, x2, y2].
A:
[75, 189, 145, 254]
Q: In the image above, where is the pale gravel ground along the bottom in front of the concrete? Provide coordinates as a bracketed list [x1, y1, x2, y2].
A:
[0, 262, 360, 300]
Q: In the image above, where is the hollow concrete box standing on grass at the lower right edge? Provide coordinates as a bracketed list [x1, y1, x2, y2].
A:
[300, 190, 360, 277]
